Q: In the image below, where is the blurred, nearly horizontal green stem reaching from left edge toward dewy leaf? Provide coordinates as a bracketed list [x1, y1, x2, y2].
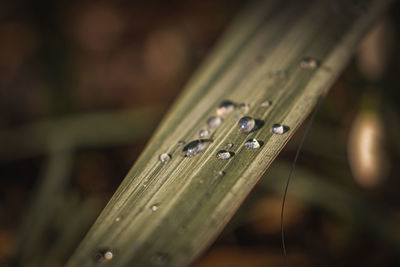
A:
[0, 106, 163, 162]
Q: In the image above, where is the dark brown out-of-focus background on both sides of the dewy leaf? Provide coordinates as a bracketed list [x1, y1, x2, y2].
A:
[0, 0, 400, 267]
